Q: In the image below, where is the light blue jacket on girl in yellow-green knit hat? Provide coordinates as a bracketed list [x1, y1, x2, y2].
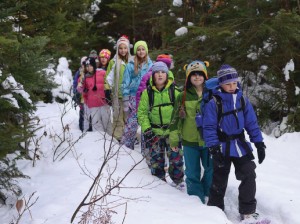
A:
[121, 57, 153, 98]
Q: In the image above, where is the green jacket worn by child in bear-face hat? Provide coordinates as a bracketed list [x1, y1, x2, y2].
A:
[169, 87, 204, 147]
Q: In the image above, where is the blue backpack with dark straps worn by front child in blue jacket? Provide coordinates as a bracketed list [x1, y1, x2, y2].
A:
[195, 77, 245, 138]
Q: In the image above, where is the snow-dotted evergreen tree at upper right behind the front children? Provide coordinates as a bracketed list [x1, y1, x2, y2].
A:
[172, 0, 300, 130]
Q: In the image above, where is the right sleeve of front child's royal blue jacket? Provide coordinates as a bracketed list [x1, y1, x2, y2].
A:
[244, 97, 263, 143]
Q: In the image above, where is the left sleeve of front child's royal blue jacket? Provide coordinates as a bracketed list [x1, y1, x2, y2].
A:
[203, 99, 220, 147]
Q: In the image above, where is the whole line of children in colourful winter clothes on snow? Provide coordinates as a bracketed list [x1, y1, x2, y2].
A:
[74, 36, 266, 223]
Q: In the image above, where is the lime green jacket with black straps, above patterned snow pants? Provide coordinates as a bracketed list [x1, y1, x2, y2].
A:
[137, 77, 180, 136]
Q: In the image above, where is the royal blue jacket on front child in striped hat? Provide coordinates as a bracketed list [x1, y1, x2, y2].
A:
[203, 86, 263, 157]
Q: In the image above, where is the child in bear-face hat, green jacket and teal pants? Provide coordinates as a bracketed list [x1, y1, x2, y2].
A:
[170, 61, 213, 203]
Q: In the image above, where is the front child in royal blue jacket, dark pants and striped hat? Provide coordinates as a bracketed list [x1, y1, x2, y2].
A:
[203, 65, 266, 221]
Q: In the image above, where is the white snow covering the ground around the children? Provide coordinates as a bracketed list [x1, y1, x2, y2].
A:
[0, 64, 300, 224]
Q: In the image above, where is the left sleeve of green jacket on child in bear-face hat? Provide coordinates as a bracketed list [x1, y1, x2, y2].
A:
[169, 91, 182, 147]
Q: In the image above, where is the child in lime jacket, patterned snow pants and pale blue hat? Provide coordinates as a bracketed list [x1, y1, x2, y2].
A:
[138, 62, 184, 185]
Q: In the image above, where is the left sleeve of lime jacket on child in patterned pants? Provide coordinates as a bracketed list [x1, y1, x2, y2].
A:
[137, 90, 151, 132]
